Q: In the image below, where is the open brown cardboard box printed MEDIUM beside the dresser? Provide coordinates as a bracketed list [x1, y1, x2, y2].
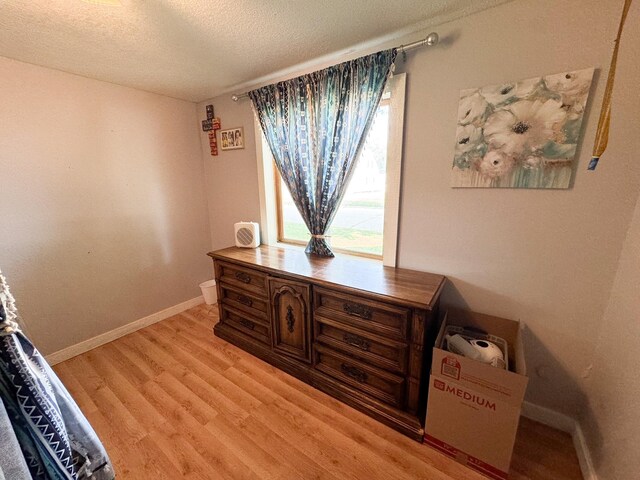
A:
[424, 310, 529, 479]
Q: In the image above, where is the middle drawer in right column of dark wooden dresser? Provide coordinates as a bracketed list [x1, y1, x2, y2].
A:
[314, 314, 407, 374]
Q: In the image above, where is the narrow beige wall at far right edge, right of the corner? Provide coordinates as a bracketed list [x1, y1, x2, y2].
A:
[583, 191, 640, 480]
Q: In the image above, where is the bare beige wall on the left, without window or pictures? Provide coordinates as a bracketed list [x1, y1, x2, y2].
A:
[0, 57, 211, 354]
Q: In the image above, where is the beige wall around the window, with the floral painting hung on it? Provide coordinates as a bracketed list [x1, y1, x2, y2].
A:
[198, 0, 640, 428]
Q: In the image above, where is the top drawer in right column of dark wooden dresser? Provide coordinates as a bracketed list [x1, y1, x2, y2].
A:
[314, 287, 410, 341]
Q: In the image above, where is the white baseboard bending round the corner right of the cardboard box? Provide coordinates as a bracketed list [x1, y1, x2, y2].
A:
[522, 402, 598, 480]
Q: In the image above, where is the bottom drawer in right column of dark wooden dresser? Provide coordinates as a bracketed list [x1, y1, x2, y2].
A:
[314, 344, 405, 408]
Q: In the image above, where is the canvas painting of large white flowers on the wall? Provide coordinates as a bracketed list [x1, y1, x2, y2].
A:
[451, 68, 593, 188]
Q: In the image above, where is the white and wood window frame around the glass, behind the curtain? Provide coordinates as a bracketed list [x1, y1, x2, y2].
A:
[254, 73, 406, 267]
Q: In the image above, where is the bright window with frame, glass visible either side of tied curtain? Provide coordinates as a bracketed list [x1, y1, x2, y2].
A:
[256, 74, 406, 266]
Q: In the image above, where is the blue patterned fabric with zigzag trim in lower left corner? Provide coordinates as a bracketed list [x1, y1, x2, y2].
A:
[0, 272, 115, 480]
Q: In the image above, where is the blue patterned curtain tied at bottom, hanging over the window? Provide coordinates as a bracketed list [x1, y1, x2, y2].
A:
[249, 49, 396, 257]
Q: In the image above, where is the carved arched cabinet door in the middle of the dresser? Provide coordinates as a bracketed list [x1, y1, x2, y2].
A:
[269, 278, 311, 363]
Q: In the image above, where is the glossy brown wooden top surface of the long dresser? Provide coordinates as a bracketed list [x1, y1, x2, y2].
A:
[208, 245, 445, 309]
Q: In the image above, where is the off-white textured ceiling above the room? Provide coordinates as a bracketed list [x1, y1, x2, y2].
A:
[0, 0, 506, 101]
